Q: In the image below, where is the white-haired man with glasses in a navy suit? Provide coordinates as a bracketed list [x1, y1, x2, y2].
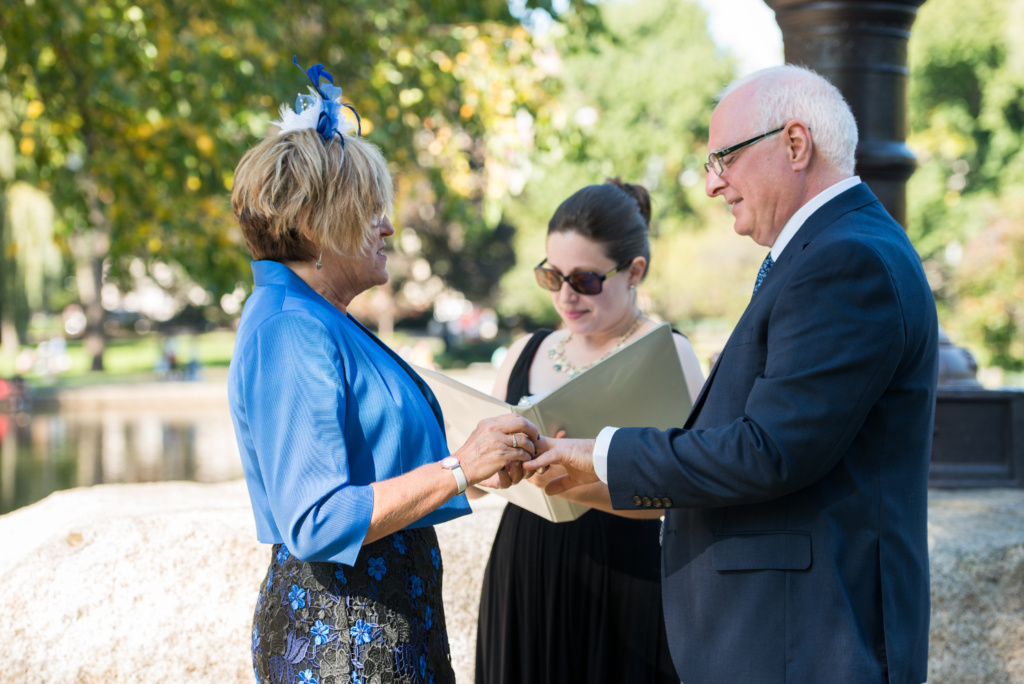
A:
[526, 66, 938, 684]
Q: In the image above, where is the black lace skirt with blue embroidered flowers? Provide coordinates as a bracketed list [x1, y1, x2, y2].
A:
[252, 527, 455, 684]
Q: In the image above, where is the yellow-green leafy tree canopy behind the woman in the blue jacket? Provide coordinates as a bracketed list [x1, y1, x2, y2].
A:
[0, 0, 593, 369]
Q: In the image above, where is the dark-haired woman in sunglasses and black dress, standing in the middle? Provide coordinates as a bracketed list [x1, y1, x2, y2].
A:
[476, 179, 703, 684]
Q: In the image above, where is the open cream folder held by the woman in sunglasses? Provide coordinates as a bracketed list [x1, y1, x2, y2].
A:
[416, 324, 690, 522]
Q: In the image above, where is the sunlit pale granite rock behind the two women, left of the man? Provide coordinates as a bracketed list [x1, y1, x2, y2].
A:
[0, 481, 503, 684]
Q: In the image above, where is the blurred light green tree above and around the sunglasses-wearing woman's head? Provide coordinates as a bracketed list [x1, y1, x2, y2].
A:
[501, 0, 763, 325]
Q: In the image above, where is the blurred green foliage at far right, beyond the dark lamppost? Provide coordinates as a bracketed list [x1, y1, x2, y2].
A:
[907, 0, 1024, 371]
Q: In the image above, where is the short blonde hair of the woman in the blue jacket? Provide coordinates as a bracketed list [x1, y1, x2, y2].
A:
[231, 129, 394, 261]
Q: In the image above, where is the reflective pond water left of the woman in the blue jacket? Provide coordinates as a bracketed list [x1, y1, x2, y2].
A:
[0, 404, 243, 514]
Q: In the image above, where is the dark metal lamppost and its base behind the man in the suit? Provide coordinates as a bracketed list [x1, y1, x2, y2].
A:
[764, 0, 1024, 487]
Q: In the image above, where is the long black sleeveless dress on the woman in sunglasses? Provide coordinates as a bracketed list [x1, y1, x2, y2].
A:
[476, 330, 679, 684]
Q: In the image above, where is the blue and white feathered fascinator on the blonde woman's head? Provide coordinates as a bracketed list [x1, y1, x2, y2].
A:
[273, 55, 362, 147]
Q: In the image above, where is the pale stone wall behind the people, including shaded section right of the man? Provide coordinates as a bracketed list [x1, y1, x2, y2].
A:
[0, 482, 1024, 684]
